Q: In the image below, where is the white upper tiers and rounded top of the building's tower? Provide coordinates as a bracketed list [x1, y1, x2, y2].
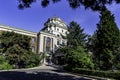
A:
[41, 17, 67, 37]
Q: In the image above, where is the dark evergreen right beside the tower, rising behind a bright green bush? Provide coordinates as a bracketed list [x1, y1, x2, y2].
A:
[67, 21, 87, 48]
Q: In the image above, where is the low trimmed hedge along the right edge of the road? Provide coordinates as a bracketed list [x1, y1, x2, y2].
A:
[65, 68, 120, 80]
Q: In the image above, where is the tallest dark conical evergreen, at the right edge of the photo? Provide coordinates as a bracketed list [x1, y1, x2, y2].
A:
[93, 9, 120, 70]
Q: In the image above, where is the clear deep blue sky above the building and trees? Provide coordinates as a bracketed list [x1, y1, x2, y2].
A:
[0, 0, 120, 35]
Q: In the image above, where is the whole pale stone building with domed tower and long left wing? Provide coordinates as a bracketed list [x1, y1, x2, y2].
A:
[0, 17, 68, 63]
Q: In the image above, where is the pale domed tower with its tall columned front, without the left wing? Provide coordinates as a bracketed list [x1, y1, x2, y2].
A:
[38, 17, 68, 53]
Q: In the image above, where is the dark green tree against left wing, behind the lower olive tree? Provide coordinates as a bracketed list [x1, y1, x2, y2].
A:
[0, 32, 30, 53]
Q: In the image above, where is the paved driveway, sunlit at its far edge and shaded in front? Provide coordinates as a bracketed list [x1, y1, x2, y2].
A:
[0, 66, 92, 80]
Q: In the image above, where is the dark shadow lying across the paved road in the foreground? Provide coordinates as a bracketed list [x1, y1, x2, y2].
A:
[0, 71, 91, 80]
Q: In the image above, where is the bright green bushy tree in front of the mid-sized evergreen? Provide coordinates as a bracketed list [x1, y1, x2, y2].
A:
[64, 46, 94, 69]
